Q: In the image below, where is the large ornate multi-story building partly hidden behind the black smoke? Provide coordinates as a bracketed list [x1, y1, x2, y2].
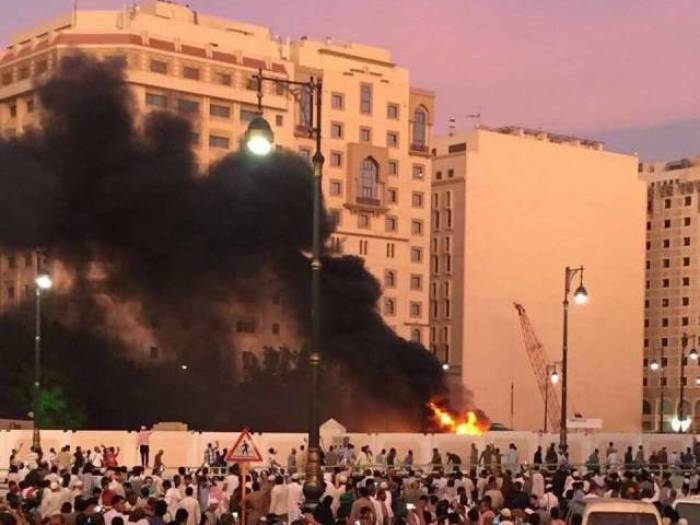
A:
[0, 0, 434, 364]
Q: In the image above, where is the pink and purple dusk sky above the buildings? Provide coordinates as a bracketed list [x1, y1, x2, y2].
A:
[0, 0, 700, 156]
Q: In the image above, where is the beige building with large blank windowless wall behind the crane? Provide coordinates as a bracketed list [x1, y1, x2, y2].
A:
[430, 127, 645, 431]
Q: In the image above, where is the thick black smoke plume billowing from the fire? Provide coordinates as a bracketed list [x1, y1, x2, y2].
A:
[0, 54, 445, 430]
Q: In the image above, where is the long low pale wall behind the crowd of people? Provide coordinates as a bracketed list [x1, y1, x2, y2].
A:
[0, 429, 693, 468]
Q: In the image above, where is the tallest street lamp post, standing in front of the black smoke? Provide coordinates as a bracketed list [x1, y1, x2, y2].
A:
[244, 70, 325, 507]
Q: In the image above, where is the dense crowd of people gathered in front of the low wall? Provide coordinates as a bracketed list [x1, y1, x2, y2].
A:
[0, 436, 700, 525]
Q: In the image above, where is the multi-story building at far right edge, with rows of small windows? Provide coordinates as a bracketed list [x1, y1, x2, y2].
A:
[639, 156, 700, 431]
